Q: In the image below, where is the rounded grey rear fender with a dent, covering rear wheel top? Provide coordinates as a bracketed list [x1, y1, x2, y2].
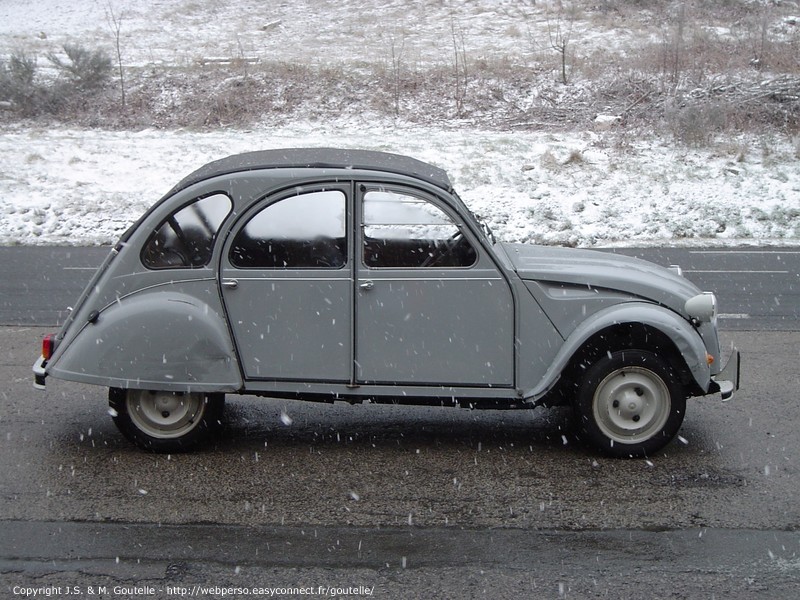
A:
[46, 290, 242, 392]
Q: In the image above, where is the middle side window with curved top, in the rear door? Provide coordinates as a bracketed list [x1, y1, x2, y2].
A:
[230, 190, 347, 269]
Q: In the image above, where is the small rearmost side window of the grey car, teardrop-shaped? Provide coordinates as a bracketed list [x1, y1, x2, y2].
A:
[142, 194, 232, 269]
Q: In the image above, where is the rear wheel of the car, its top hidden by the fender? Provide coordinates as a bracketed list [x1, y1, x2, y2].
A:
[108, 388, 225, 453]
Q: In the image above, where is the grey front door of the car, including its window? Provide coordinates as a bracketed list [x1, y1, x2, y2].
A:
[355, 184, 514, 387]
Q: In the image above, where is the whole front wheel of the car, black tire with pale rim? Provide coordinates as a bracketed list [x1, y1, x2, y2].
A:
[575, 350, 686, 458]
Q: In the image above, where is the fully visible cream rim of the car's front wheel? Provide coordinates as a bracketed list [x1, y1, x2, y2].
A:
[592, 367, 672, 444]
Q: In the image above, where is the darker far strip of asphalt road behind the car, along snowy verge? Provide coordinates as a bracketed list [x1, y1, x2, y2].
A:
[0, 247, 800, 331]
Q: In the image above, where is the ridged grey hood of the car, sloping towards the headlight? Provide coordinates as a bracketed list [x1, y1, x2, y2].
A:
[502, 244, 700, 315]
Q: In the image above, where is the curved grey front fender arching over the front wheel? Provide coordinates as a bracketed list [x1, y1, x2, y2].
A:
[523, 302, 711, 401]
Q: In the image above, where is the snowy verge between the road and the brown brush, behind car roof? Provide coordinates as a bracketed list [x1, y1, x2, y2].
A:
[0, 123, 800, 246]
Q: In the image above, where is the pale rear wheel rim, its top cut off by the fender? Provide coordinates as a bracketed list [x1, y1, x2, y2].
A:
[126, 390, 205, 439]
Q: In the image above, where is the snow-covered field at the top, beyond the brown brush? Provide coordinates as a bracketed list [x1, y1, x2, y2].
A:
[0, 0, 636, 66]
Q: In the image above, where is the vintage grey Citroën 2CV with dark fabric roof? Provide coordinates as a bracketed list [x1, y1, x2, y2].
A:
[34, 148, 739, 457]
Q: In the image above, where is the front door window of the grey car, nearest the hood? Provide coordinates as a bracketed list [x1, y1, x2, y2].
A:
[363, 190, 477, 268]
